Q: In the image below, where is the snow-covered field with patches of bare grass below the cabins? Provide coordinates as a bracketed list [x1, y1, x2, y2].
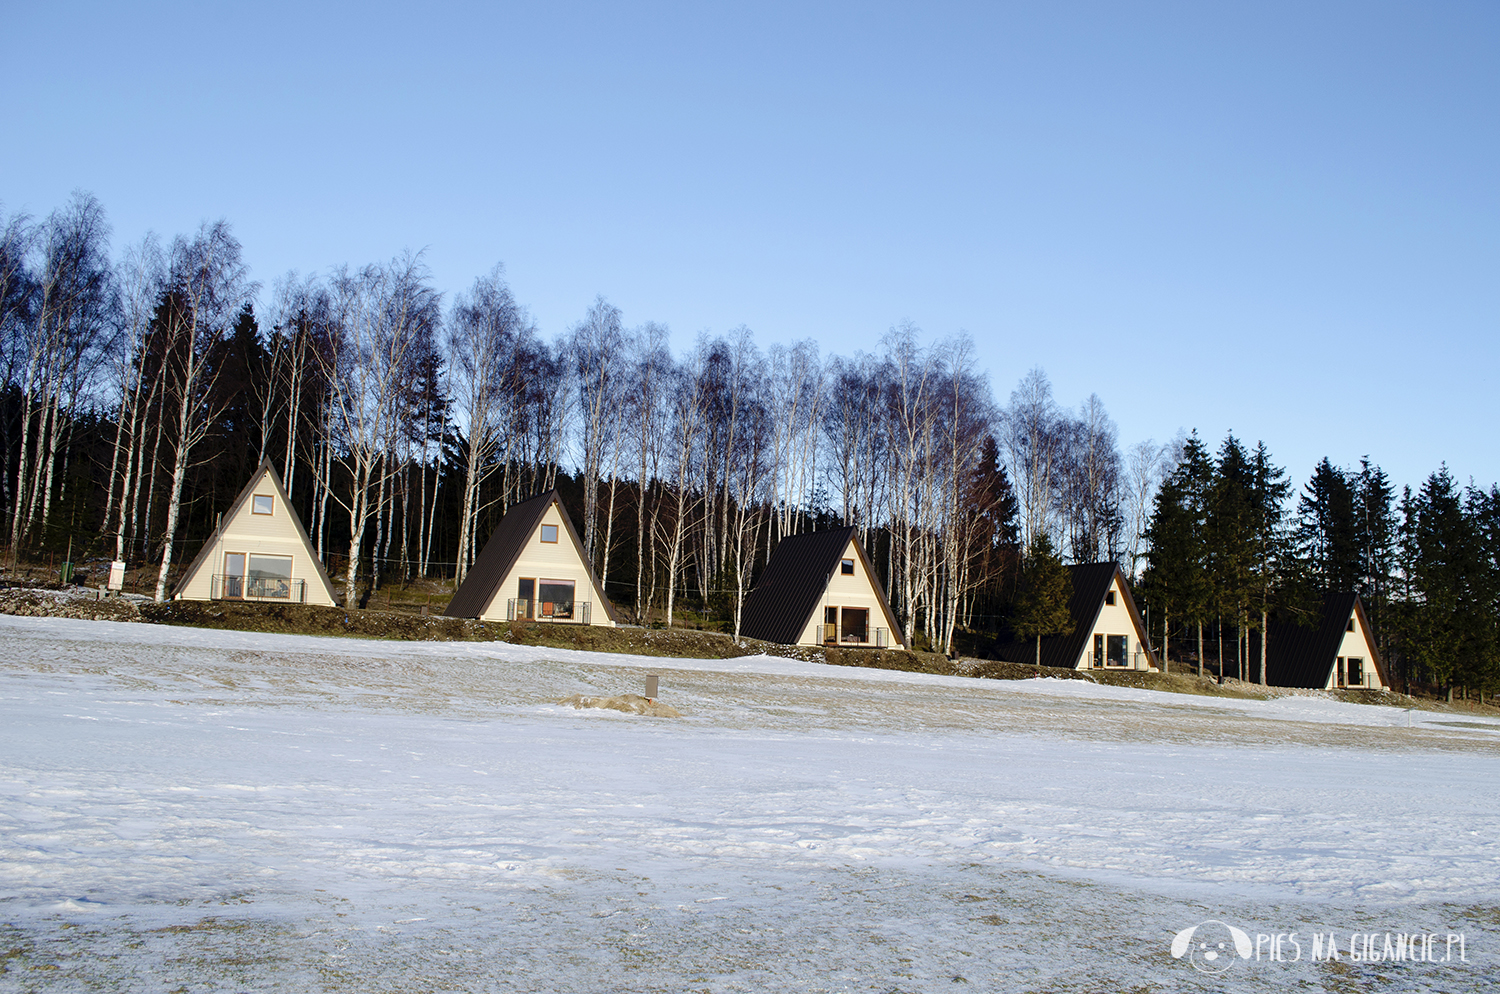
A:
[0, 616, 1500, 993]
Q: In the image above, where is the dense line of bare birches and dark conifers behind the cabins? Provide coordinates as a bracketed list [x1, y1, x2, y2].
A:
[0, 193, 1500, 691]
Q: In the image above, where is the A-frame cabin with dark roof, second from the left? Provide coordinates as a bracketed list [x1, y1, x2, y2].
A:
[444, 490, 620, 628]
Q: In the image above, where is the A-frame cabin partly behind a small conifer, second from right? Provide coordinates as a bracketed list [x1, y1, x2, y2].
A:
[998, 562, 1160, 672]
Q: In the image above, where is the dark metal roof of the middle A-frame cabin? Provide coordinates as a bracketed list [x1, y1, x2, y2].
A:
[740, 526, 906, 646]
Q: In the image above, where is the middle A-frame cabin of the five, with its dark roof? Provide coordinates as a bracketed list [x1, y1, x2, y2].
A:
[740, 526, 906, 648]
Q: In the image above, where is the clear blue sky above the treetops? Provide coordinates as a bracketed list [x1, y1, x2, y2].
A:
[0, 0, 1500, 497]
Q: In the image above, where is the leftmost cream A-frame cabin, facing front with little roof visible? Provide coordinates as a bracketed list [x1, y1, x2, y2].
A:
[173, 459, 338, 606]
